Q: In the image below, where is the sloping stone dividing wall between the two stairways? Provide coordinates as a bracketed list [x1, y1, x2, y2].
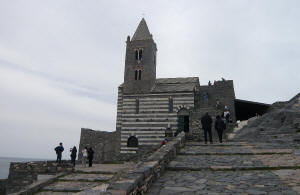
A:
[103, 132, 185, 195]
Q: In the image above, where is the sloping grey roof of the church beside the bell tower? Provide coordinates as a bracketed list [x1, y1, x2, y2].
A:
[151, 77, 199, 93]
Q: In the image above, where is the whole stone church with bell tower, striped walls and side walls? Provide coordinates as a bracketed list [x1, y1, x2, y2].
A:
[79, 18, 269, 162]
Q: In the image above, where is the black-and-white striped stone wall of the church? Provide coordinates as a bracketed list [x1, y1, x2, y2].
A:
[117, 92, 194, 154]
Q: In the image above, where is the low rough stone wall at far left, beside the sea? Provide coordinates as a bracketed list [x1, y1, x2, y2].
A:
[6, 161, 72, 193]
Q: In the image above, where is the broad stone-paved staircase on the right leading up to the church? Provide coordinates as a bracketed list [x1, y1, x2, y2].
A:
[147, 142, 300, 195]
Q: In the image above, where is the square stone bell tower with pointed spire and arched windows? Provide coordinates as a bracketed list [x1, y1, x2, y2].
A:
[124, 18, 157, 94]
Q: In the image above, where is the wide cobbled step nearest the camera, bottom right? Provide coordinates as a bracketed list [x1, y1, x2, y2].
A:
[147, 169, 300, 195]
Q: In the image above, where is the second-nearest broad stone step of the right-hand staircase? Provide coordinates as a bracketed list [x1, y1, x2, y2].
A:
[167, 154, 300, 170]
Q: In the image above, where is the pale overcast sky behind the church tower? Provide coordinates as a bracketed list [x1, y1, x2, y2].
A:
[0, 0, 300, 158]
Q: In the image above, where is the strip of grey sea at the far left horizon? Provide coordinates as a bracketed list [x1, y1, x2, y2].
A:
[0, 156, 49, 179]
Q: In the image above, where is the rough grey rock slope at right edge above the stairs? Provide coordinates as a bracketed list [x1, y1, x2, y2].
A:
[235, 93, 300, 145]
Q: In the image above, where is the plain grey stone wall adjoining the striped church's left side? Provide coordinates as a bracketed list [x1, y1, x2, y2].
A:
[78, 128, 120, 163]
